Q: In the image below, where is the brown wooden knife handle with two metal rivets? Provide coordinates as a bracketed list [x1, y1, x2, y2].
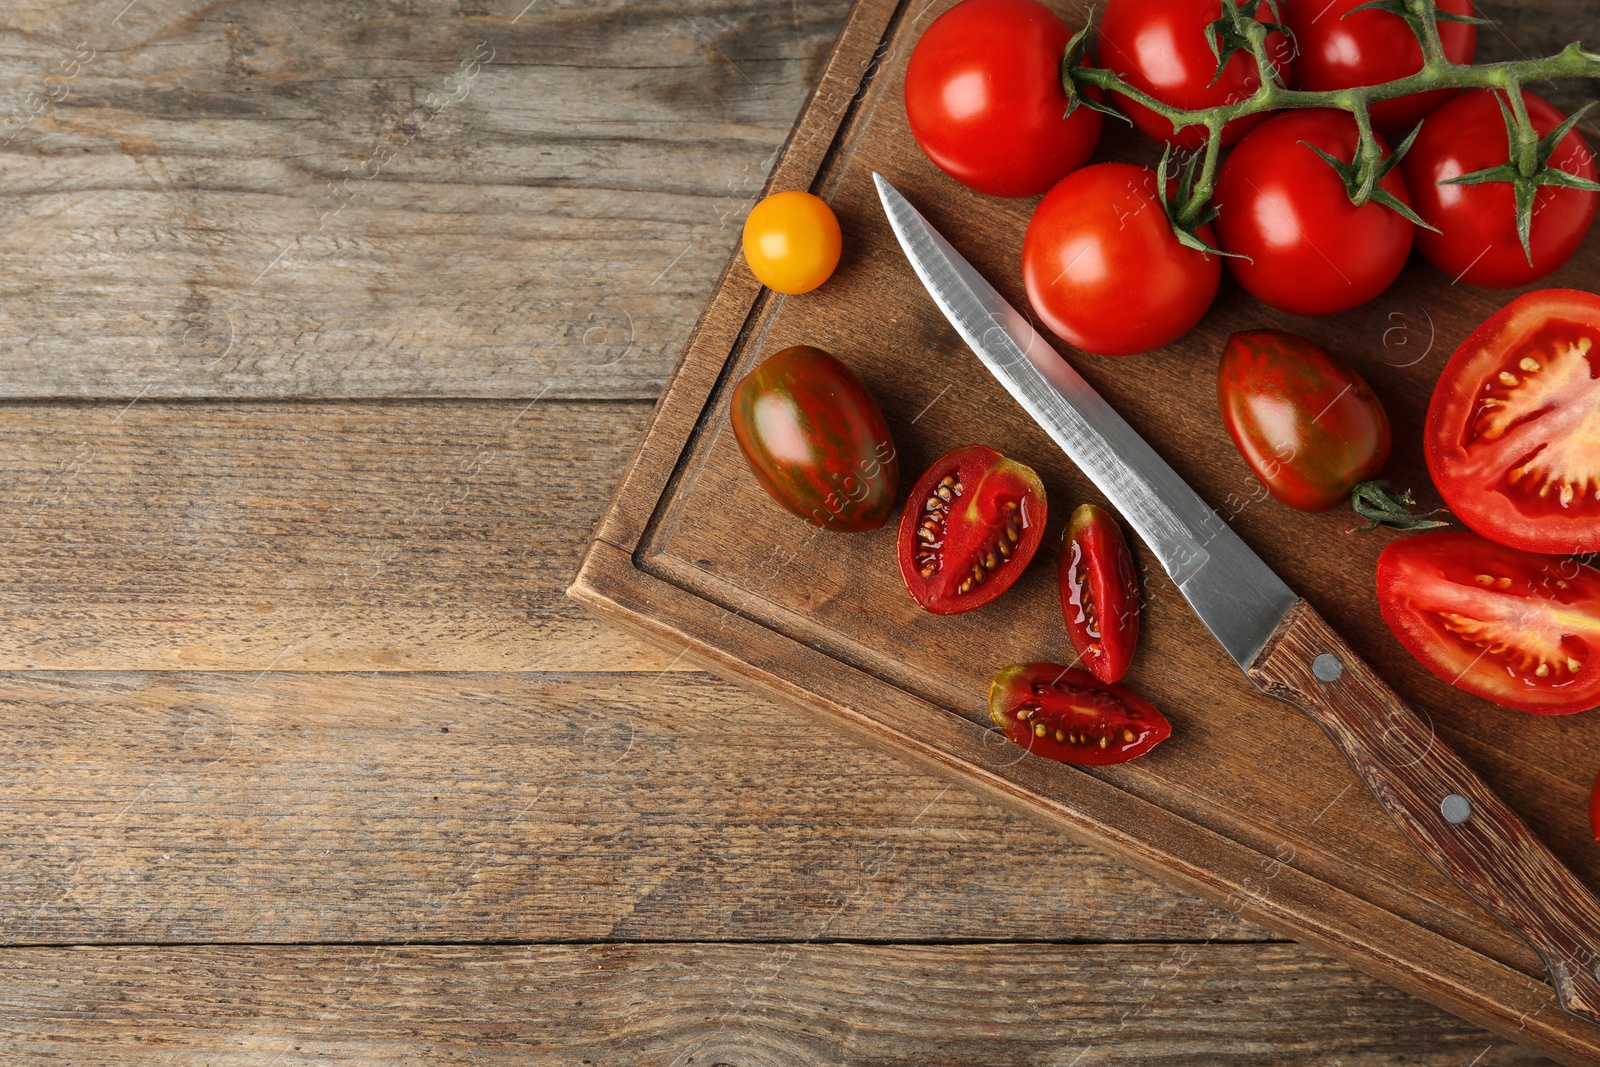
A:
[1245, 600, 1600, 1022]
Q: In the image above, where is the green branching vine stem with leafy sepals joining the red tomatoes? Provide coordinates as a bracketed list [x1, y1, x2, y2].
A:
[1061, 0, 1600, 255]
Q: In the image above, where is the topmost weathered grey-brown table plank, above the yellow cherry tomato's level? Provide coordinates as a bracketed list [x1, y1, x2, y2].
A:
[0, 0, 848, 398]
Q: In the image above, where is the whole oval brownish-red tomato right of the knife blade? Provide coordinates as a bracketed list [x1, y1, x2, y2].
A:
[1216, 330, 1389, 512]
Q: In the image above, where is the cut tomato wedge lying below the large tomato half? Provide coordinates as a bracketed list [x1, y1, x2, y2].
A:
[1378, 531, 1600, 715]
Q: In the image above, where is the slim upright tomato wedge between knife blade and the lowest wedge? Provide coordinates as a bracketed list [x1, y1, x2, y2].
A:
[1059, 504, 1139, 683]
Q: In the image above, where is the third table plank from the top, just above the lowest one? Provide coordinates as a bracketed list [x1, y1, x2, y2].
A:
[0, 672, 1266, 947]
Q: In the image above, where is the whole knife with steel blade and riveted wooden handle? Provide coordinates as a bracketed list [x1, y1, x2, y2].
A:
[872, 173, 1600, 1022]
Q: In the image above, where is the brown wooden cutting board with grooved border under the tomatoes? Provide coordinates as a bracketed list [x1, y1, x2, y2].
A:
[571, 0, 1600, 1062]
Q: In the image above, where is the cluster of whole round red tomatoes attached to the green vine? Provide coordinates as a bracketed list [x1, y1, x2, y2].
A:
[906, 0, 1600, 355]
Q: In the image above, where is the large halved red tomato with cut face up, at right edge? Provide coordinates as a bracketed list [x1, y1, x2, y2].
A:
[1422, 290, 1600, 552]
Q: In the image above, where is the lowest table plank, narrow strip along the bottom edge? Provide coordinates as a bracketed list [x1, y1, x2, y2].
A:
[0, 944, 1547, 1067]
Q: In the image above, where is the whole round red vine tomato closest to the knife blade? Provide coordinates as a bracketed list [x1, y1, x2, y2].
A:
[1022, 163, 1222, 355]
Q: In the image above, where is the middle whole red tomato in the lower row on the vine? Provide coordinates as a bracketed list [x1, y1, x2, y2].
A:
[1216, 107, 1416, 315]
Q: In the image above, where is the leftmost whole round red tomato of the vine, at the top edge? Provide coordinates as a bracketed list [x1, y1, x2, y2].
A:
[906, 0, 1101, 197]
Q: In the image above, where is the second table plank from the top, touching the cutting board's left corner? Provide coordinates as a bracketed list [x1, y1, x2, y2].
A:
[0, 400, 688, 672]
